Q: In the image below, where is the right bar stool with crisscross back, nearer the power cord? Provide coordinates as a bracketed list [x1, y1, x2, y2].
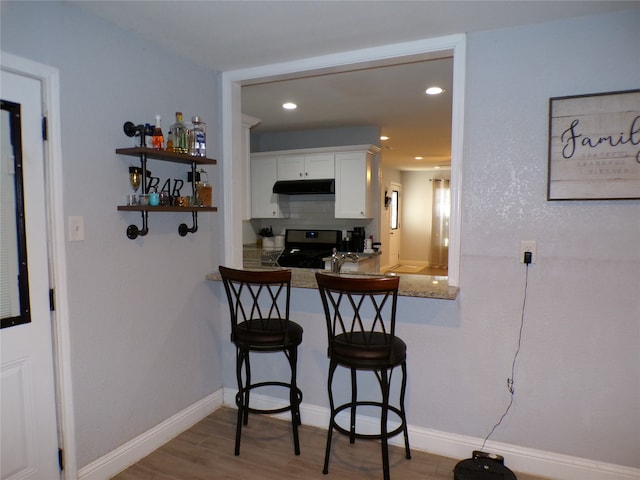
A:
[316, 273, 411, 480]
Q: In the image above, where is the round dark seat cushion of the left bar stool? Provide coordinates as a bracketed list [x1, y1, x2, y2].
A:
[233, 318, 302, 349]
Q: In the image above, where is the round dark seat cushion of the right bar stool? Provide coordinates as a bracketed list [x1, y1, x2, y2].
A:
[330, 332, 407, 369]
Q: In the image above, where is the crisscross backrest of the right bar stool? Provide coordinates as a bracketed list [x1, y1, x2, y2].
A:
[316, 273, 400, 348]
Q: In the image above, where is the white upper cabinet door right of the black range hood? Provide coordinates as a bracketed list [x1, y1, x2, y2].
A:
[335, 152, 373, 218]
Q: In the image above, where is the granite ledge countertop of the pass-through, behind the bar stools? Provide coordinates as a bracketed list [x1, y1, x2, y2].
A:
[207, 267, 459, 300]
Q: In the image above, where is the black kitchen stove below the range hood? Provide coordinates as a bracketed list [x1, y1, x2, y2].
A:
[278, 229, 342, 268]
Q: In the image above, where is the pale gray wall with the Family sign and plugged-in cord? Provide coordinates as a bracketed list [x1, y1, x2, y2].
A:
[230, 10, 640, 468]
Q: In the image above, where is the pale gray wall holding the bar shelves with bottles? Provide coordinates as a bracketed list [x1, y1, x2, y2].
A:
[1, 2, 223, 467]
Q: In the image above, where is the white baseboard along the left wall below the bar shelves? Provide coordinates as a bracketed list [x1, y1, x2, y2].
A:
[78, 389, 223, 480]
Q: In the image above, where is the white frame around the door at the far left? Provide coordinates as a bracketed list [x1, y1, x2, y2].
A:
[0, 51, 78, 479]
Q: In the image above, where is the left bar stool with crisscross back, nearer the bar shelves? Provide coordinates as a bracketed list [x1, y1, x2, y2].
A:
[219, 266, 302, 455]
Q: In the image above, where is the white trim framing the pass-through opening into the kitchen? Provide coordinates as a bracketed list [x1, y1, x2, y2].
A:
[221, 34, 466, 286]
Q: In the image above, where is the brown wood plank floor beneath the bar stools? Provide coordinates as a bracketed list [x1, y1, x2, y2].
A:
[113, 407, 552, 480]
